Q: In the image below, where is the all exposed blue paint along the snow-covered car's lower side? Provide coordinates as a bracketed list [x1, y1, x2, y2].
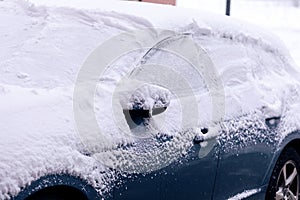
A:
[14, 126, 300, 200]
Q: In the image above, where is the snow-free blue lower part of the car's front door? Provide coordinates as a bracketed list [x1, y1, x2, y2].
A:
[113, 144, 218, 200]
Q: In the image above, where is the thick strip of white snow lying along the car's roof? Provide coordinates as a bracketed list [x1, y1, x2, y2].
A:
[30, 0, 292, 58]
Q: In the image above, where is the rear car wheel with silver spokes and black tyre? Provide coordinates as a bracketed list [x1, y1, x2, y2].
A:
[266, 148, 300, 200]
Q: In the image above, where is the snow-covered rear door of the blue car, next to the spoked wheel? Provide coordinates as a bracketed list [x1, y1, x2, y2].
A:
[200, 34, 298, 199]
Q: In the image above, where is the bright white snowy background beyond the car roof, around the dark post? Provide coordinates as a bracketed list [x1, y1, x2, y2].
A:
[176, 0, 300, 66]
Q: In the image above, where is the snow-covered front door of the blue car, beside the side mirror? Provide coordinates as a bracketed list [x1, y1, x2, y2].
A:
[114, 35, 222, 199]
